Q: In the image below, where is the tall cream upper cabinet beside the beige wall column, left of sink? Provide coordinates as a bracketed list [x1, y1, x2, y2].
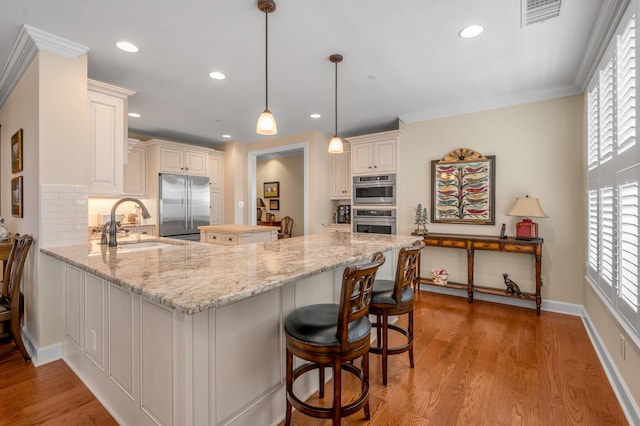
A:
[88, 80, 135, 195]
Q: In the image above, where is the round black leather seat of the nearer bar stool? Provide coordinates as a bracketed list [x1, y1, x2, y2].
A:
[284, 303, 371, 349]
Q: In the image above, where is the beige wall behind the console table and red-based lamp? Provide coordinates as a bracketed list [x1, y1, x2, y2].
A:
[398, 96, 585, 304]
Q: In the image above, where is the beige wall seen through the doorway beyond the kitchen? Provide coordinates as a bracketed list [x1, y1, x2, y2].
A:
[256, 155, 304, 237]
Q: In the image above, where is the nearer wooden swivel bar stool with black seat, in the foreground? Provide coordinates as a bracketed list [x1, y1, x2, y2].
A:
[284, 252, 384, 426]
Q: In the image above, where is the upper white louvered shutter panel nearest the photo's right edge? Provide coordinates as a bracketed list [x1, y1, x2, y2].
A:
[616, 19, 636, 155]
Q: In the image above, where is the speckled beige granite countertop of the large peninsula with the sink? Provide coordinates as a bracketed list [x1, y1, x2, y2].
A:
[40, 232, 421, 315]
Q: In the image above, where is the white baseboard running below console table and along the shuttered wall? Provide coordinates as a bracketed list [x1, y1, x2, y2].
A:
[420, 285, 640, 425]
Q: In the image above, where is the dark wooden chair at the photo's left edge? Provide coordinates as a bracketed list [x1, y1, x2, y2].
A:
[0, 235, 33, 361]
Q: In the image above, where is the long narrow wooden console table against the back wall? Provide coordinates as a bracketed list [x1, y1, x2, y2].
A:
[420, 234, 543, 315]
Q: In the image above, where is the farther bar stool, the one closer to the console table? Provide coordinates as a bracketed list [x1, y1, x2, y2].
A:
[369, 241, 424, 386]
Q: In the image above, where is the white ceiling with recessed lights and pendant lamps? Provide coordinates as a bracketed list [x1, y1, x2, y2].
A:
[0, 0, 626, 150]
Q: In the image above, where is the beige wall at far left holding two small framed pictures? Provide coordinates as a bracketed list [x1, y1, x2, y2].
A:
[0, 51, 89, 348]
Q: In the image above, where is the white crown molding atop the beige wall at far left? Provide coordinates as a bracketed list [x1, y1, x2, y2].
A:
[0, 25, 89, 107]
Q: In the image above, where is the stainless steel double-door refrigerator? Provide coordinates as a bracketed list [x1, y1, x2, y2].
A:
[158, 173, 210, 241]
